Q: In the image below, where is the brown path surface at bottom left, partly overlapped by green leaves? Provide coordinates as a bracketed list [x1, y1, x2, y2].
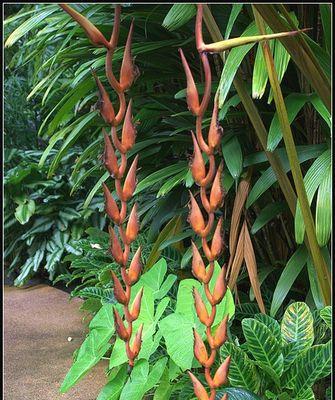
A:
[4, 284, 107, 400]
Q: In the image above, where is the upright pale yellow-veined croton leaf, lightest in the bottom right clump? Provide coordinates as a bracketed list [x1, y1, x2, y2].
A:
[281, 302, 314, 352]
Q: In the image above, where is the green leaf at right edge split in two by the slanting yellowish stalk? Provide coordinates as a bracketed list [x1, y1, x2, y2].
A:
[294, 150, 331, 244]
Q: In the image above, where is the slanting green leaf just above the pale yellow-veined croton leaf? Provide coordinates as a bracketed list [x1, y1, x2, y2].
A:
[270, 246, 308, 317]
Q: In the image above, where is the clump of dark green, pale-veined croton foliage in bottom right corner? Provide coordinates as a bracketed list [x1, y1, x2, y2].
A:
[221, 302, 331, 400]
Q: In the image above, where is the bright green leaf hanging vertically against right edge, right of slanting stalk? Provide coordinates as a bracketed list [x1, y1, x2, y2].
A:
[315, 165, 332, 247]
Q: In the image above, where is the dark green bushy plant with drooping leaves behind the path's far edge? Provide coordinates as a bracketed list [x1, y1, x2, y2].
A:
[4, 149, 105, 286]
